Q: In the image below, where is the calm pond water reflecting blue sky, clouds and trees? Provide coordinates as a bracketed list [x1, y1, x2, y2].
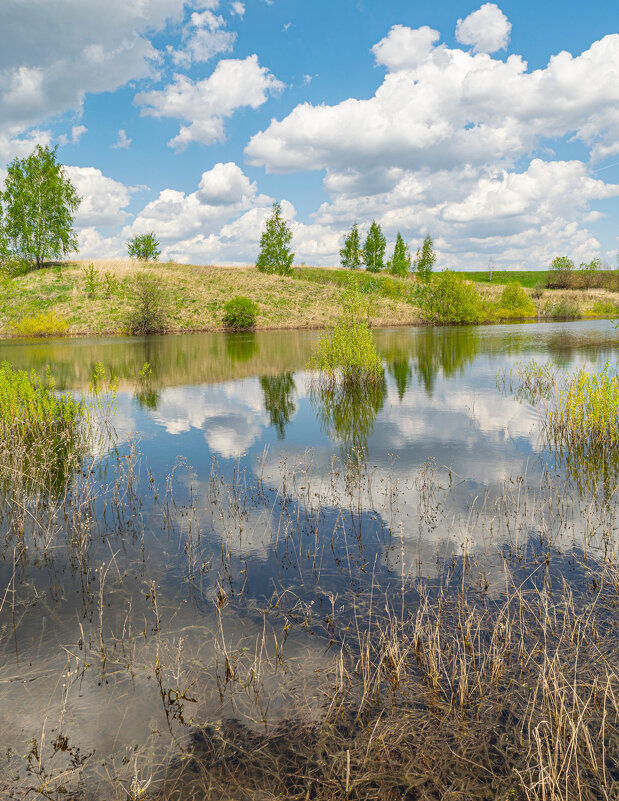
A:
[0, 321, 619, 799]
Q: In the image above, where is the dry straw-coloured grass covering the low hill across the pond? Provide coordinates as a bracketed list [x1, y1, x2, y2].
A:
[0, 260, 420, 335]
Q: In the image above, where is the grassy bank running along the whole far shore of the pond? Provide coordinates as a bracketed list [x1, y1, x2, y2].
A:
[0, 261, 619, 337]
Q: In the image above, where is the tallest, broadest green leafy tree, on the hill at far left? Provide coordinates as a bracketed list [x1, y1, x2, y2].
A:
[0, 145, 81, 268]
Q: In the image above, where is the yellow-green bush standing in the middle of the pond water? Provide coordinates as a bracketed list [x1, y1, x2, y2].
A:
[308, 286, 382, 385]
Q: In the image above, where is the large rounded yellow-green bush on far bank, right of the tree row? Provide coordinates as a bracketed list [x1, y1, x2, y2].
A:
[417, 270, 486, 325]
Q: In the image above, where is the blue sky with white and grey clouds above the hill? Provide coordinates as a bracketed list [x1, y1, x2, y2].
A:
[0, 0, 619, 269]
